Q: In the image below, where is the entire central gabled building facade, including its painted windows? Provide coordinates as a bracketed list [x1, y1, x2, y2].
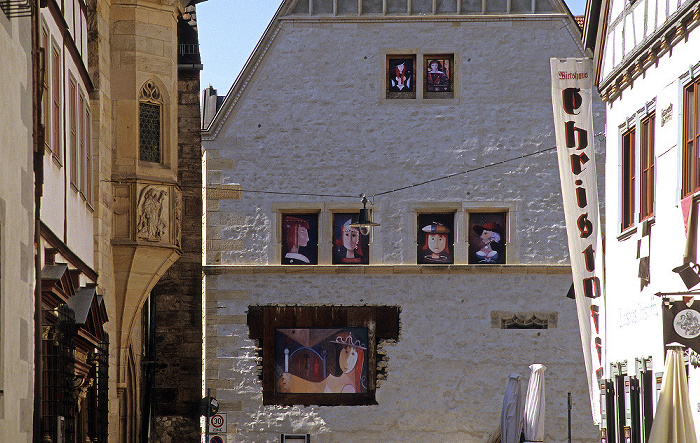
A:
[202, 0, 601, 442]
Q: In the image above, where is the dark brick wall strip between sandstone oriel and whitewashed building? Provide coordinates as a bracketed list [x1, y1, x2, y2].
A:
[154, 67, 202, 443]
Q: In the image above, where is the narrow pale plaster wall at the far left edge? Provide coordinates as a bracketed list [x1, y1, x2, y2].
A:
[0, 11, 34, 443]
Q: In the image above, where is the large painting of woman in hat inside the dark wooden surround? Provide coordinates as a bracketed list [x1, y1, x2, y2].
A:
[275, 327, 368, 394]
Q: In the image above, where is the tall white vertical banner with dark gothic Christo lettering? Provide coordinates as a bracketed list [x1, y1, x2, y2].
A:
[550, 58, 605, 424]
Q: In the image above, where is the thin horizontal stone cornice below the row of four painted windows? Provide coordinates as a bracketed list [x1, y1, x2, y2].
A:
[203, 264, 571, 275]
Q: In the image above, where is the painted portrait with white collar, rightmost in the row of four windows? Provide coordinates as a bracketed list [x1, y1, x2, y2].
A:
[469, 212, 506, 264]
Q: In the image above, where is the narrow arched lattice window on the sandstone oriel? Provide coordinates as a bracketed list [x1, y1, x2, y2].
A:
[139, 81, 163, 163]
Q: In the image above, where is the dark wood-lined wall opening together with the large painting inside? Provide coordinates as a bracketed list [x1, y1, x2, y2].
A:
[248, 306, 399, 406]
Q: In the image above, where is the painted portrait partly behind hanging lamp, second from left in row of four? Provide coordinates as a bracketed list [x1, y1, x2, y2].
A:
[333, 213, 369, 265]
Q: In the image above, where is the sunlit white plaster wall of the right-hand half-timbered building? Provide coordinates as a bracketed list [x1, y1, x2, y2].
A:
[605, 12, 700, 442]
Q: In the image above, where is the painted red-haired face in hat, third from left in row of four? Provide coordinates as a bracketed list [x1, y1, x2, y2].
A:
[418, 213, 454, 264]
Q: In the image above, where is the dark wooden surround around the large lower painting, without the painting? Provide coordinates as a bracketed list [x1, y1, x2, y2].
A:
[247, 305, 400, 406]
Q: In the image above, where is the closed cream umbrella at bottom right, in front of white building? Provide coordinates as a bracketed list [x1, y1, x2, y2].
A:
[649, 346, 697, 443]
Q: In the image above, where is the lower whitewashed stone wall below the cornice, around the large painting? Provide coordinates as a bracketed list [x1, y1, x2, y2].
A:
[206, 266, 596, 443]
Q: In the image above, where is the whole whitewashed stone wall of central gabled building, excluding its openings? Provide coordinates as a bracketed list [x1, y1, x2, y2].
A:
[203, 9, 601, 443]
